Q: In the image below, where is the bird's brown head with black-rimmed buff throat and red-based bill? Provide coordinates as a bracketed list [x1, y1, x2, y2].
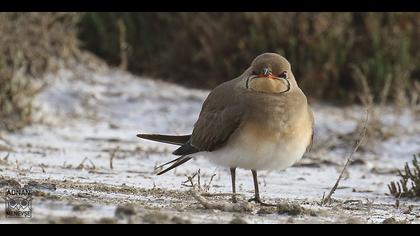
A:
[245, 53, 296, 94]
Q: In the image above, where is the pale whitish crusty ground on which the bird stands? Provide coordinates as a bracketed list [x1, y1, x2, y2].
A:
[0, 67, 420, 223]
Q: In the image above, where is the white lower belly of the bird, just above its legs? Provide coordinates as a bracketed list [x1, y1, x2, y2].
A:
[199, 122, 312, 170]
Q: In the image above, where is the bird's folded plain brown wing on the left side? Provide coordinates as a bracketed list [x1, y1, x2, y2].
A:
[191, 78, 245, 151]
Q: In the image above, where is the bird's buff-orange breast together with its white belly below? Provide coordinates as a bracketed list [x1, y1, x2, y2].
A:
[207, 103, 312, 170]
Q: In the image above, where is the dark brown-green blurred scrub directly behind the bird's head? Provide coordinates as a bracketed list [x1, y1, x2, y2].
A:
[80, 12, 420, 103]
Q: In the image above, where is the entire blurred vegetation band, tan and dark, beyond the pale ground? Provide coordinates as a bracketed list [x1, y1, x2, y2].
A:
[0, 12, 420, 129]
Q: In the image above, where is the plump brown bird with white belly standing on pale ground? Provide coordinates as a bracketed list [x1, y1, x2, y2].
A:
[137, 53, 314, 205]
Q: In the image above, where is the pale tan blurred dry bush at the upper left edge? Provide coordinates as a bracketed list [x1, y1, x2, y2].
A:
[0, 12, 80, 130]
